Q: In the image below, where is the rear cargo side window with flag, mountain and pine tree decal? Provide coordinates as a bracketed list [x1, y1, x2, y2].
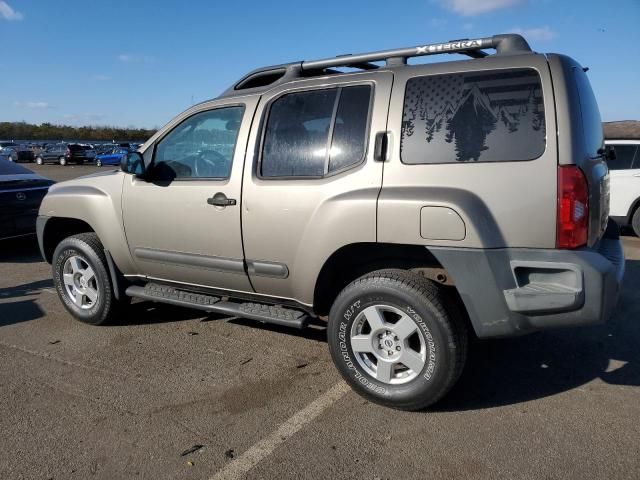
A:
[400, 69, 546, 164]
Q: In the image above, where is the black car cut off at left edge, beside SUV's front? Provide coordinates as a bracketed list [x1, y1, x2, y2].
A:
[0, 160, 55, 239]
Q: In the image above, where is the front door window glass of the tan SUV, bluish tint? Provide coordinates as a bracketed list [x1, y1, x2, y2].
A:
[154, 107, 244, 180]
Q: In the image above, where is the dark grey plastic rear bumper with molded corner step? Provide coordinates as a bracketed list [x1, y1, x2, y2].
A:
[431, 225, 624, 338]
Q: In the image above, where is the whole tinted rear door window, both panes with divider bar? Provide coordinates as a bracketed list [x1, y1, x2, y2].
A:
[260, 85, 371, 177]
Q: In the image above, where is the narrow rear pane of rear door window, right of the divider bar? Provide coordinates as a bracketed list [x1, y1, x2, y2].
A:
[329, 85, 371, 172]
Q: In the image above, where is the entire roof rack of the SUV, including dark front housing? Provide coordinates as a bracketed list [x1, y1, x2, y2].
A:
[222, 33, 531, 97]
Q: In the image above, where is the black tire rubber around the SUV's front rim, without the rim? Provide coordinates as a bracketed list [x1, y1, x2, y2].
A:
[51, 233, 126, 325]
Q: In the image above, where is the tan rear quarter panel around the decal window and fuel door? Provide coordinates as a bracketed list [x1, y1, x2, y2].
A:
[378, 55, 558, 248]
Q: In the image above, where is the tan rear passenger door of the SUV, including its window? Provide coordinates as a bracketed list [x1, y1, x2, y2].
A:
[242, 71, 393, 304]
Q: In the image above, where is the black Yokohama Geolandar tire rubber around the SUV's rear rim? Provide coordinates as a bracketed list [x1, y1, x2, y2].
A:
[327, 270, 468, 410]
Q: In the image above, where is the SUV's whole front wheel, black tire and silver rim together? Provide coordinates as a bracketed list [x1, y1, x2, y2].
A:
[51, 233, 122, 325]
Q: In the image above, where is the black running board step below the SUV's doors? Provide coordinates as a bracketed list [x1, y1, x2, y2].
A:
[126, 283, 310, 329]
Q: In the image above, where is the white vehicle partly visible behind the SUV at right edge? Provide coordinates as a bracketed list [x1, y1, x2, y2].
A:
[606, 140, 640, 236]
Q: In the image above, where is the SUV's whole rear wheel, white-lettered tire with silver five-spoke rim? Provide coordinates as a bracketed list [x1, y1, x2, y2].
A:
[328, 270, 467, 410]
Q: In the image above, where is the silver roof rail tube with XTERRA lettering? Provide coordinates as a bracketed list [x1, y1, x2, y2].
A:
[301, 33, 531, 70]
